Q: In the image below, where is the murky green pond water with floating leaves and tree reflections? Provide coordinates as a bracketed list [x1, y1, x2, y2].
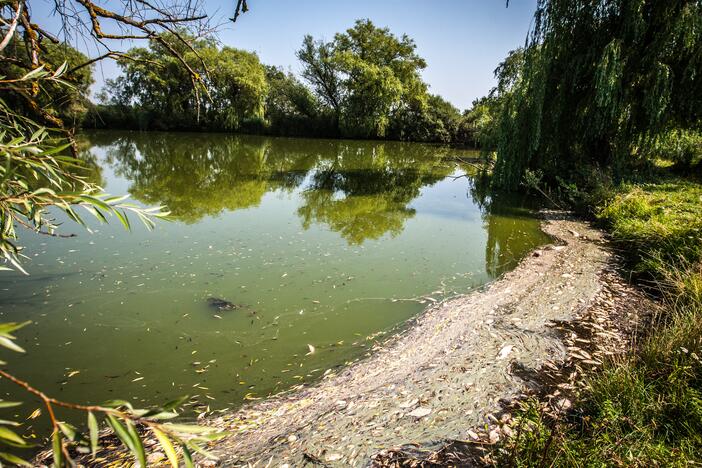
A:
[0, 132, 547, 420]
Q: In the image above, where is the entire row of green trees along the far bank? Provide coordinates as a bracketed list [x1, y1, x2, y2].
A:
[75, 20, 490, 145]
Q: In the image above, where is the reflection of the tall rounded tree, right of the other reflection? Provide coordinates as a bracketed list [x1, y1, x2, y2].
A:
[298, 142, 453, 244]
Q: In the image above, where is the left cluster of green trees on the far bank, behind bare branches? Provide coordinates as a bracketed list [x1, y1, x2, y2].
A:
[100, 32, 268, 130]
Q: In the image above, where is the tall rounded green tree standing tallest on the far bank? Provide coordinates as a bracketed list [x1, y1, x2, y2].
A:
[297, 20, 429, 138]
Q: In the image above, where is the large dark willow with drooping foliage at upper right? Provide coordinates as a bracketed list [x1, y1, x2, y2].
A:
[495, 0, 702, 188]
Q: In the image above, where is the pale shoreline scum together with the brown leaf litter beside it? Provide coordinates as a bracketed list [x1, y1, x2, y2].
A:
[38, 212, 649, 467]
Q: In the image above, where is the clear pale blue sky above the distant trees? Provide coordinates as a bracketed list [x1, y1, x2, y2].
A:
[33, 0, 536, 109]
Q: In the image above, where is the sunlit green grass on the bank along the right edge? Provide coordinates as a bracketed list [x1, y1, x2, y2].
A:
[496, 179, 702, 467]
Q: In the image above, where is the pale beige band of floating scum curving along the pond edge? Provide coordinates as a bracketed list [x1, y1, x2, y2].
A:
[210, 212, 611, 466]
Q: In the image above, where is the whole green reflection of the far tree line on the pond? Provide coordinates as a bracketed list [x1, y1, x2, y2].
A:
[91, 133, 453, 244]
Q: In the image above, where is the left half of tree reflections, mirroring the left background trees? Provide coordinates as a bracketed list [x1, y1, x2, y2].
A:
[91, 133, 316, 223]
